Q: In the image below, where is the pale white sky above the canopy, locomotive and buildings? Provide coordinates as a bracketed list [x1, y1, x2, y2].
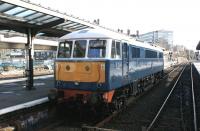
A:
[31, 0, 200, 50]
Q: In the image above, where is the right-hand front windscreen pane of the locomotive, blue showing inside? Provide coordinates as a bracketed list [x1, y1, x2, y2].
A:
[88, 40, 106, 58]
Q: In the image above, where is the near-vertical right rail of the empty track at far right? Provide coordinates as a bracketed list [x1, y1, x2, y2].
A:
[191, 63, 197, 131]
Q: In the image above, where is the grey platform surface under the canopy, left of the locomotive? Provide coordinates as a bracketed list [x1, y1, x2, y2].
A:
[0, 75, 54, 112]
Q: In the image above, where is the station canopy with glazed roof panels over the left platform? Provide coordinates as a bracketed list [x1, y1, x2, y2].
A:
[0, 0, 100, 37]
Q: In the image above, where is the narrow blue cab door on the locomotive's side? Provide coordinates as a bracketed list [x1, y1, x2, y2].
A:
[122, 43, 129, 80]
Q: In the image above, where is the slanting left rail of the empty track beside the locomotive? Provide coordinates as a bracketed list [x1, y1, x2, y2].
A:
[146, 64, 187, 131]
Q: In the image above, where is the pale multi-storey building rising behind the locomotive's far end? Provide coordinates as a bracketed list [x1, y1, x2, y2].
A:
[138, 30, 173, 49]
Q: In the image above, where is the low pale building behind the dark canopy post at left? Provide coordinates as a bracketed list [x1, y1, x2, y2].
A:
[0, 34, 58, 60]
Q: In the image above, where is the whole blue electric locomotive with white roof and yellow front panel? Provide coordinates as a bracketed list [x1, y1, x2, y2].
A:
[50, 29, 164, 109]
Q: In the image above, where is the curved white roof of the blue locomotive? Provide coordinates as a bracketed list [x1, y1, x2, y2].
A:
[60, 29, 163, 52]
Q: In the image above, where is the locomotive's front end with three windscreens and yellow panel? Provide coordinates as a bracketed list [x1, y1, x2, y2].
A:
[50, 39, 113, 102]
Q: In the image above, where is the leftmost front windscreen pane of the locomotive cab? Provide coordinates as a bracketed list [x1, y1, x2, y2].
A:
[58, 41, 72, 58]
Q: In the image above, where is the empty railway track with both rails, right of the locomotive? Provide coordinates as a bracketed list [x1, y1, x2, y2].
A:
[147, 65, 198, 131]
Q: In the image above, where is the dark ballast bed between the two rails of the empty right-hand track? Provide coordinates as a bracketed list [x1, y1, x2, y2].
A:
[152, 65, 194, 131]
